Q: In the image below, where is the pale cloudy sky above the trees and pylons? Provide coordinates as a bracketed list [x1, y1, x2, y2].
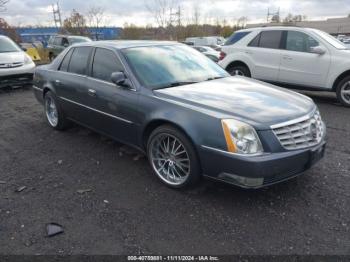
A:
[0, 0, 350, 26]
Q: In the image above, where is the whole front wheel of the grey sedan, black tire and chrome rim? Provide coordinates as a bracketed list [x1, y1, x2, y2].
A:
[147, 125, 201, 189]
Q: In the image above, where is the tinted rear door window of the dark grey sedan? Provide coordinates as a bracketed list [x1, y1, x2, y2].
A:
[68, 47, 92, 75]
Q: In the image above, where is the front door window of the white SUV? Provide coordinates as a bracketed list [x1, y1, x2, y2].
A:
[286, 31, 319, 52]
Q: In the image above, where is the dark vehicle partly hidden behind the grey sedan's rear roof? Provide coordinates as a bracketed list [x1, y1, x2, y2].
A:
[47, 35, 92, 61]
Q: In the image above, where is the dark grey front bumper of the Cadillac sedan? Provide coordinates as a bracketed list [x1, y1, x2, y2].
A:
[200, 141, 326, 189]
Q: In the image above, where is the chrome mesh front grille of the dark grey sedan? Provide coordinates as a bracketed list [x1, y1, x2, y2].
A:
[272, 110, 325, 150]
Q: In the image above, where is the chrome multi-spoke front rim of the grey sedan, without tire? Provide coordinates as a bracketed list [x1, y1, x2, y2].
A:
[149, 133, 191, 186]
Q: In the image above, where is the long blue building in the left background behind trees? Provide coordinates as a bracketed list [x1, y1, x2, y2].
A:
[11, 27, 122, 46]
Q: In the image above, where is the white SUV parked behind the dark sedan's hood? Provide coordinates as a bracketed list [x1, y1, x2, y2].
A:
[219, 27, 350, 107]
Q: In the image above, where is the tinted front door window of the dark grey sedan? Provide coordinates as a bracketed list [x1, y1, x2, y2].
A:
[92, 48, 124, 82]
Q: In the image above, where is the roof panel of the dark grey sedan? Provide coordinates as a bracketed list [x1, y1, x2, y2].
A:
[74, 40, 180, 49]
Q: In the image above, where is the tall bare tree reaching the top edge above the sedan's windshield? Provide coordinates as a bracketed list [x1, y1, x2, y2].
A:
[145, 0, 178, 28]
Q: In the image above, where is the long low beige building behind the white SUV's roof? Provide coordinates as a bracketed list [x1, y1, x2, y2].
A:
[247, 17, 350, 35]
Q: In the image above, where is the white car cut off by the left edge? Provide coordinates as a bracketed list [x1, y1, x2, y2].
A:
[0, 35, 35, 88]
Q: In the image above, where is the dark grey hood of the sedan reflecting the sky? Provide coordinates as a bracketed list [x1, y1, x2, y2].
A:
[154, 77, 316, 130]
